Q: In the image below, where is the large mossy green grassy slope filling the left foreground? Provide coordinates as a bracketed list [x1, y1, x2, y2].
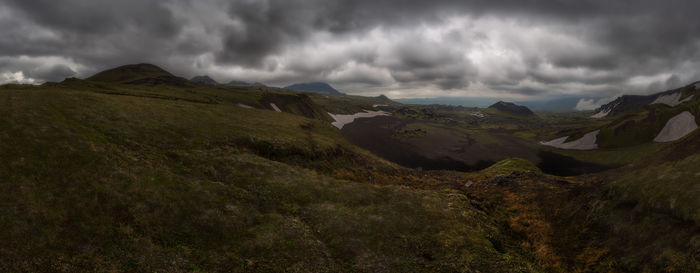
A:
[0, 82, 538, 272]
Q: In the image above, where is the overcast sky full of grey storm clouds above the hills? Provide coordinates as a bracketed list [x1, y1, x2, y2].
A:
[0, 0, 700, 110]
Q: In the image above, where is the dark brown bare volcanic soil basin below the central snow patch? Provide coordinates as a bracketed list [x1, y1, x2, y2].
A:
[341, 116, 615, 176]
